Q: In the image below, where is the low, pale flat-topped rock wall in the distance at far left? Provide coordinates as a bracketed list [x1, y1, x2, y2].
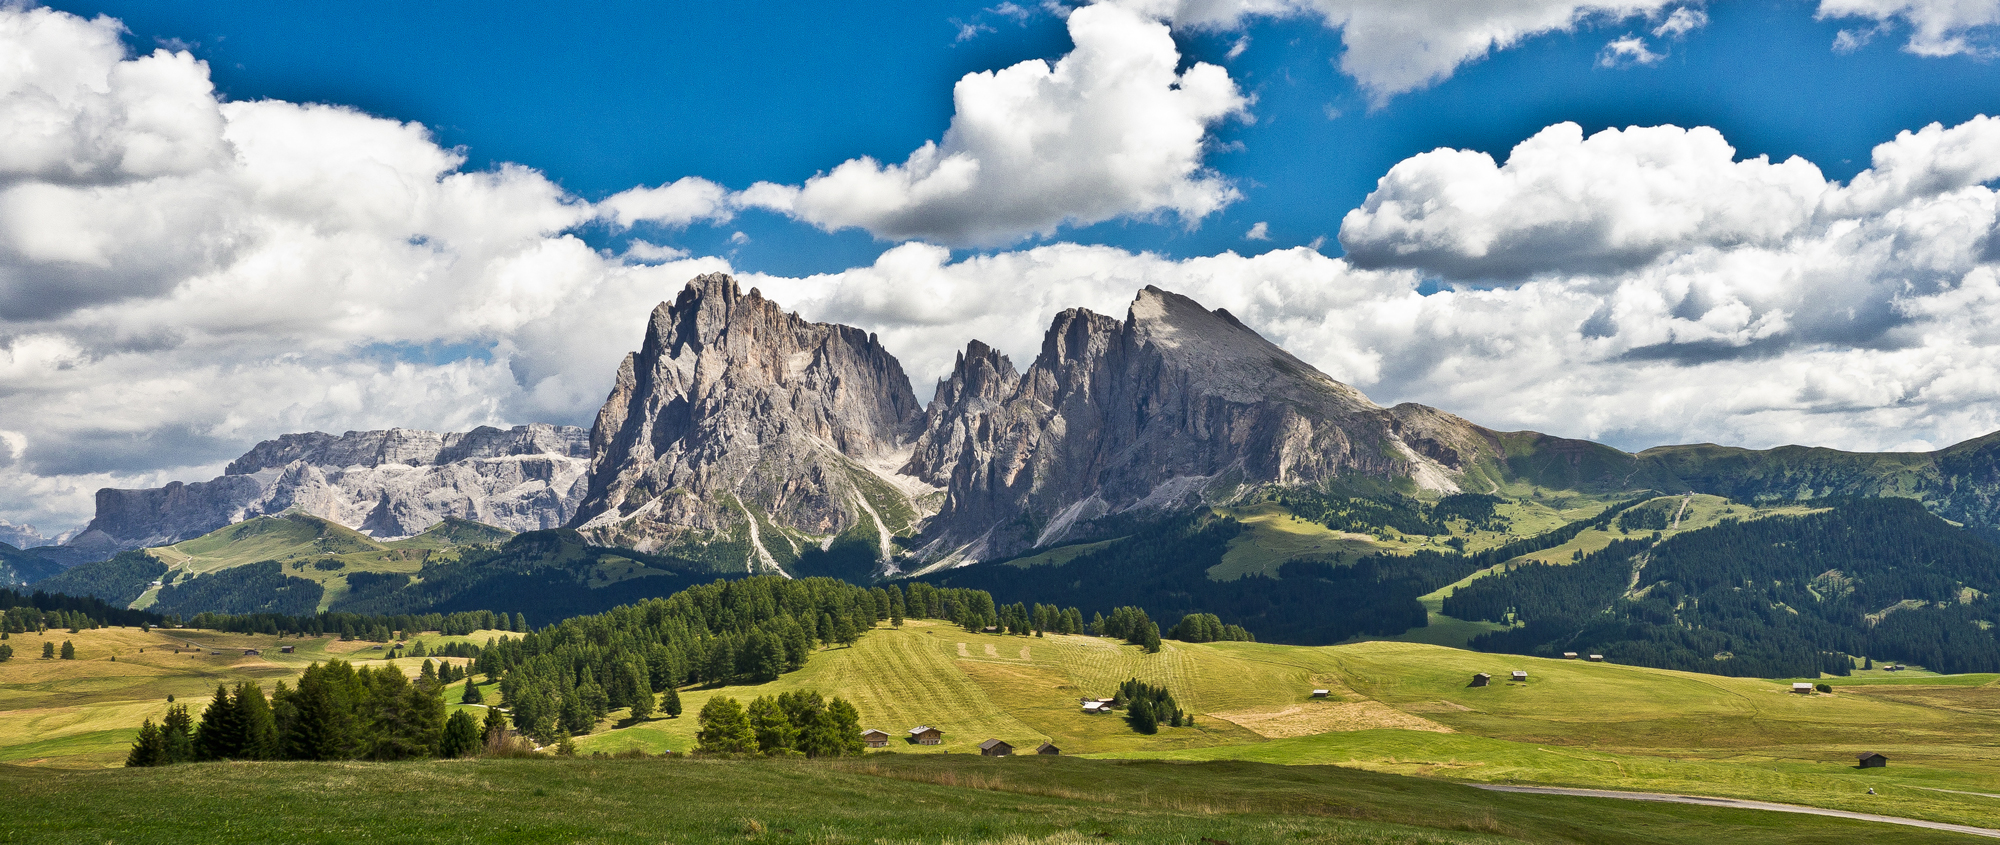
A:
[68, 425, 590, 555]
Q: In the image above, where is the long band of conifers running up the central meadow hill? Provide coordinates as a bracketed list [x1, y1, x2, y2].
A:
[474, 575, 998, 741]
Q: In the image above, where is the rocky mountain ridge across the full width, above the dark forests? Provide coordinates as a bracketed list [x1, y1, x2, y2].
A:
[44, 274, 2000, 588]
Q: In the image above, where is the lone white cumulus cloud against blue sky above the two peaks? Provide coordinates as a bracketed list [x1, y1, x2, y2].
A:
[738, 6, 1248, 244]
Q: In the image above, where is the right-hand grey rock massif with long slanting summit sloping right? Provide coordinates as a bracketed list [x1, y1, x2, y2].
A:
[906, 286, 1484, 565]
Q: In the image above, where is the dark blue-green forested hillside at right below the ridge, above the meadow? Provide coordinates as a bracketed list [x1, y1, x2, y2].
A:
[1444, 499, 2000, 677]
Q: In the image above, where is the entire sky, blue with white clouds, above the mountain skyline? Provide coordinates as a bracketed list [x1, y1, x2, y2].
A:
[0, 0, 2000, 531]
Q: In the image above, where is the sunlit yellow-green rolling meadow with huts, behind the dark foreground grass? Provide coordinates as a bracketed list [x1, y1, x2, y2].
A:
[15, 621, 2000, 841]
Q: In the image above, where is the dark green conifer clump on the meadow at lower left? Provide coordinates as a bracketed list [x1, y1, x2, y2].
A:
[126, 661, 488, 767]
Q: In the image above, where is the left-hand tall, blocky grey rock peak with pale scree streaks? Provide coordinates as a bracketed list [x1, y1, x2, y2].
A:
[572, 274, 926, 571]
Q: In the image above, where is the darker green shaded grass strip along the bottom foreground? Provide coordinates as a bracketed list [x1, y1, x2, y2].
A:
[0, 753, 1964, 845]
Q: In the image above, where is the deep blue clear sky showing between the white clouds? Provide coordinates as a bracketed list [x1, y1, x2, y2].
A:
[52, 0, 2000, 274]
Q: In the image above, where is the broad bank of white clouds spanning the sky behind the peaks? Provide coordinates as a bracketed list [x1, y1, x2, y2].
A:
[0, 6, 2000, 531]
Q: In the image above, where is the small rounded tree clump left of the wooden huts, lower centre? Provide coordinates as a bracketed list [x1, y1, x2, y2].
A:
[694, 691, 864, 757]
